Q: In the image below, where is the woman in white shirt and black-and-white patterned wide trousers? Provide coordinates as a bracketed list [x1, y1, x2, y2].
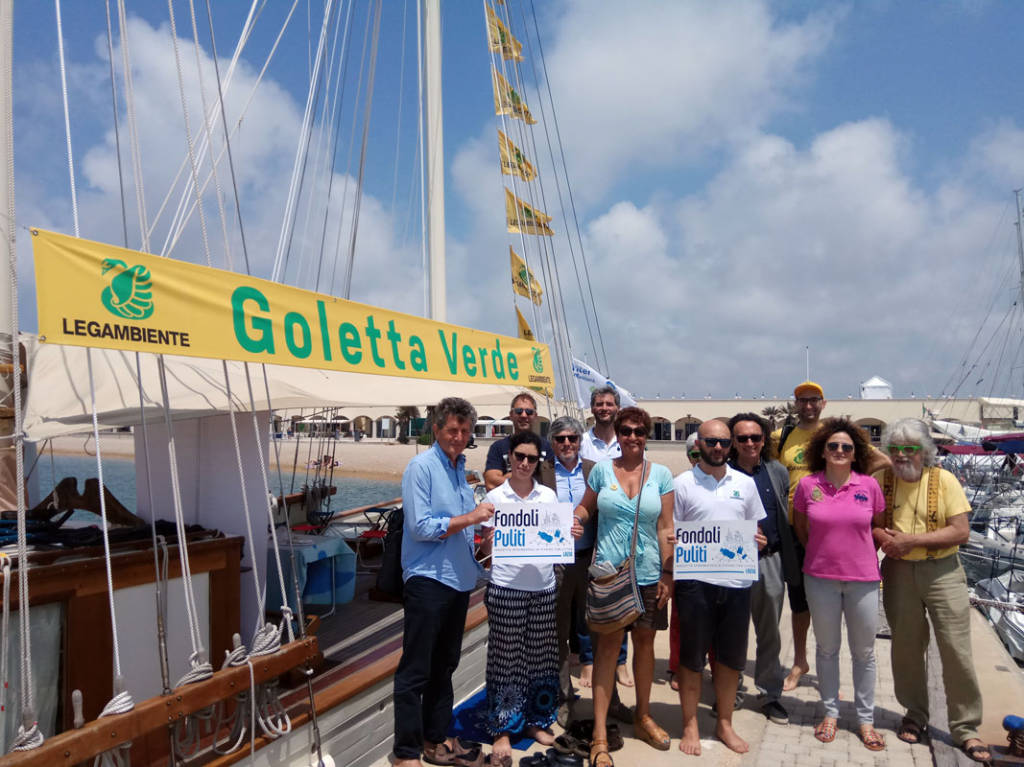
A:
[484, 431, 558, 767]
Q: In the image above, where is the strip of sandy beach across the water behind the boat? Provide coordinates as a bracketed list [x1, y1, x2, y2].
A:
[46, 432, 690, 479]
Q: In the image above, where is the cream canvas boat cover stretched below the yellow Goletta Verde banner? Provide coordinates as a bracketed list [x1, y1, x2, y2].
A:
[20, 334, 544, 441]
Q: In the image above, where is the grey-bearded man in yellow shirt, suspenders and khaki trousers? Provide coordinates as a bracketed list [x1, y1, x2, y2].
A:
[874, 418, 991, 762]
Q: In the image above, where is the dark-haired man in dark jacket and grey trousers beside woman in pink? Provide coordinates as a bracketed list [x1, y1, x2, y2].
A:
[729, 413, 801, 724]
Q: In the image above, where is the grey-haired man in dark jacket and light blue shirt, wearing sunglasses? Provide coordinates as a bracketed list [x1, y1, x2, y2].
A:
[541, 416, 596, 727]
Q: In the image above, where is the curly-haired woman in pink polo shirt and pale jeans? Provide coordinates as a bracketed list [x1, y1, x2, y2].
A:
[793, 418, 886, 751]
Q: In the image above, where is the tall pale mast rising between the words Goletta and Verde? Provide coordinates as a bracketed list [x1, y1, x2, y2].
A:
[423, 0, 447, 323]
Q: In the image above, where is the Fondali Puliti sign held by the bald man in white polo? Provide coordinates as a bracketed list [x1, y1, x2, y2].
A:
[673, 519, 758, 581]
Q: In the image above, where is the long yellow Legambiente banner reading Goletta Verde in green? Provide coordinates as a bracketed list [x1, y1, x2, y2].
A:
[32, 229, 554, 395]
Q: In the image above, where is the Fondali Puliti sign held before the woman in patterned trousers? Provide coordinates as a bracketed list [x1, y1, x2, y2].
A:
[490, 503, 575, 564]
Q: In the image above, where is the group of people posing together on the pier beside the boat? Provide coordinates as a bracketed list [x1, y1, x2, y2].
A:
[394, 381, 991, 767]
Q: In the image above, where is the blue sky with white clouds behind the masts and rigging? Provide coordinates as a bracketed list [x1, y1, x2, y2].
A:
[14, 0, 1024, 398]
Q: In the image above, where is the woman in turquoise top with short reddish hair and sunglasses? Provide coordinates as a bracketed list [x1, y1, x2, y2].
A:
[572, 408, 673, 767]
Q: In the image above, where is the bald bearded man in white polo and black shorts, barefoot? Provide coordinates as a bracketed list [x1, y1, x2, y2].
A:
[675, 421, 766, 756]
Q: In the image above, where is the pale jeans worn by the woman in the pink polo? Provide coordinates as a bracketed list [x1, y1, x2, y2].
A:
[804, 572, 879, 724]
